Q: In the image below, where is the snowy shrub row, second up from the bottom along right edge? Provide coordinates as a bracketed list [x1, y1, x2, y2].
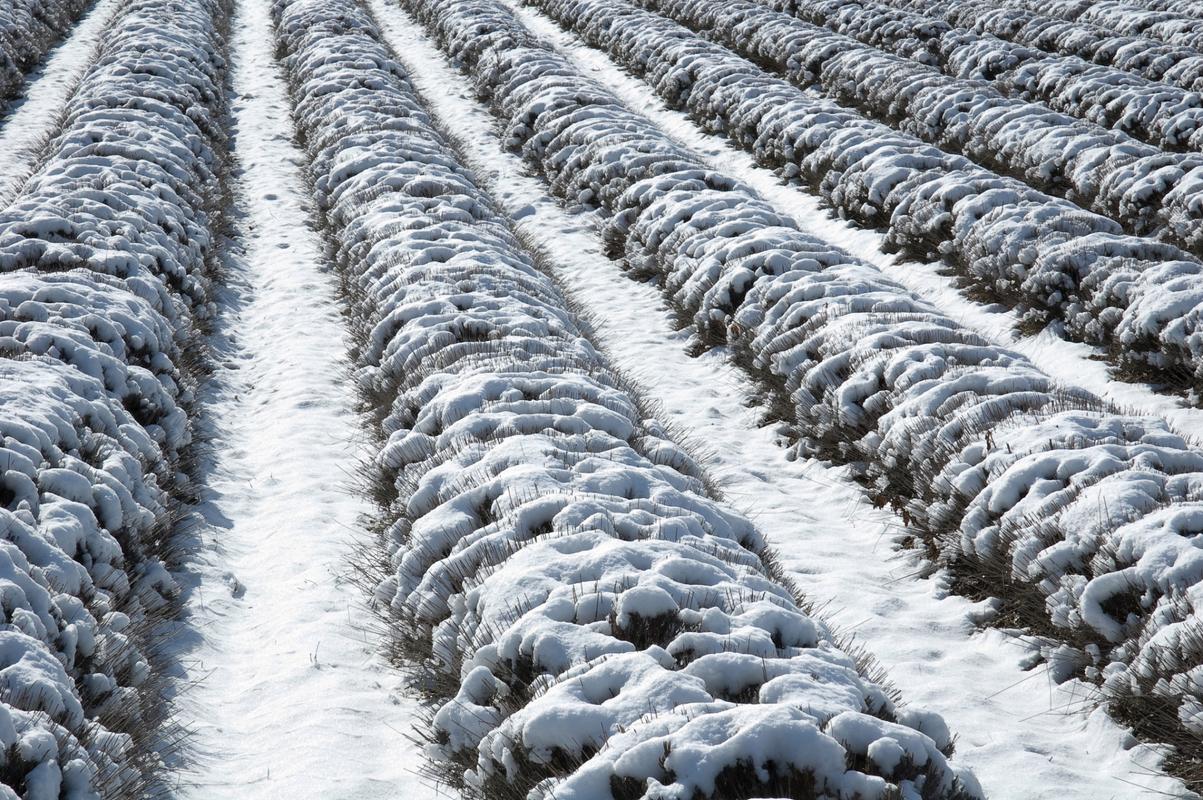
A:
[519, 0, 1203, 399]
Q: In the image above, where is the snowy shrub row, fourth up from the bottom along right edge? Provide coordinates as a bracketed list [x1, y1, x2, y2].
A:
[784, 0, 1203, 152]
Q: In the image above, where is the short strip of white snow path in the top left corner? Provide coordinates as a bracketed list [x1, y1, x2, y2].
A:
[0, 0, 123, 208]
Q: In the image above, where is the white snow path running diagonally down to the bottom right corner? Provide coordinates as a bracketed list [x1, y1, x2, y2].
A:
[368, 0, 1180, 800]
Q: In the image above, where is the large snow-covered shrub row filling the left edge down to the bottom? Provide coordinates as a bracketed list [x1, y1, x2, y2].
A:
[0, 0, 226, 800]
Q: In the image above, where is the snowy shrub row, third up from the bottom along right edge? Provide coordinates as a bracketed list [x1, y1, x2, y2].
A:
[642, 0, 1203, 260]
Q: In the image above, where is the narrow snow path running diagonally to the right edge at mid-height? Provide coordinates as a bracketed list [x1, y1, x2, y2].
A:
[495, 0, 1203, 442]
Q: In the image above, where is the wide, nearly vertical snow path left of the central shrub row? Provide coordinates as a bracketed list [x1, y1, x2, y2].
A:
[180, 0, 437, 800]
